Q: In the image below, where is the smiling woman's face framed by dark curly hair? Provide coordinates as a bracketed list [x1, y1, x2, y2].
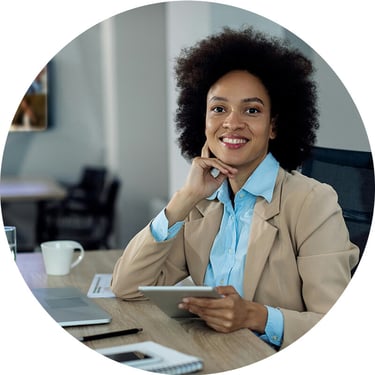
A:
[206, 70, 276, 175]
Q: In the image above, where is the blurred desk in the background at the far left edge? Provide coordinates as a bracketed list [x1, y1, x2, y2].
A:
[0, 177, 67, 250]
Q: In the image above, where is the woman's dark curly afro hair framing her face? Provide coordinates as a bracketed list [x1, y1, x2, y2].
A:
[175, 27, 319, 171]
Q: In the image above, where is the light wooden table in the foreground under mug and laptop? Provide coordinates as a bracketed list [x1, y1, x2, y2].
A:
[17, 250, 275, 374]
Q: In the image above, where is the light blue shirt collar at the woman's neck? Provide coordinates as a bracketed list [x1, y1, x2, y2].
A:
[207, 153, 279, 203]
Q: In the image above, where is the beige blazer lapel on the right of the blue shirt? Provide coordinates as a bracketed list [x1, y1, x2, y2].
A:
[244, 168, 285, 300]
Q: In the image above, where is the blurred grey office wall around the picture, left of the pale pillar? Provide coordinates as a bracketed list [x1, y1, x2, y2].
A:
[2, 4, 168, 248]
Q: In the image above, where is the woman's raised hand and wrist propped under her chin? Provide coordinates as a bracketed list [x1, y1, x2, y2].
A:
[165, 142, 237, 226]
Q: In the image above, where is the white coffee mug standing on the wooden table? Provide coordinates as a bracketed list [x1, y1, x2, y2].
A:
[40, 240, 85, 275]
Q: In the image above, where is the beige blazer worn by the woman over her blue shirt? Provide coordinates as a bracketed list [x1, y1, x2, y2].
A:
[112, 168, 359, 347]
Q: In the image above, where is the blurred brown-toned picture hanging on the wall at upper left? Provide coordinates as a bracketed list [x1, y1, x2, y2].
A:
[10, 66, 48, 131]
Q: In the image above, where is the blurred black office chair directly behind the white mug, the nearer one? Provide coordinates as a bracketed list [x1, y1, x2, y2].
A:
[43, 177, 121, 250]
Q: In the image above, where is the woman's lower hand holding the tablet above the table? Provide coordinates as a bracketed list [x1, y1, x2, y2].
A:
[179, 286, 268, 334]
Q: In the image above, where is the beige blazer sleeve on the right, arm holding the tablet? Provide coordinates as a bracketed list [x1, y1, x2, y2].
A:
[280, 184, 359, 347]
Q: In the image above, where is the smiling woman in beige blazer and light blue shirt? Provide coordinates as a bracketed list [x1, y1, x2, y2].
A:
[112, 28, 359, 348]
